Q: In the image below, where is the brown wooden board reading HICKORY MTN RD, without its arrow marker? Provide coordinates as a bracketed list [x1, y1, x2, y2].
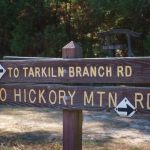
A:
[0, 84, 150, 112]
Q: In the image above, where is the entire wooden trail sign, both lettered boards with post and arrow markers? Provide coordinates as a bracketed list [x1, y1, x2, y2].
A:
[0, 42, 150, 150]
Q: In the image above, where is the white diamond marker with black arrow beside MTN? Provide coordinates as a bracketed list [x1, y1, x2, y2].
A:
[115, 97, 136, 117]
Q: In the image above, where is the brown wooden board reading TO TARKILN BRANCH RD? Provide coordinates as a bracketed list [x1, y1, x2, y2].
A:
[0, 57, 150, 83]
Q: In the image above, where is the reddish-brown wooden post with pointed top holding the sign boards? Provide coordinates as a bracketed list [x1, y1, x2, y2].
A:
[62, 41, 82, 150]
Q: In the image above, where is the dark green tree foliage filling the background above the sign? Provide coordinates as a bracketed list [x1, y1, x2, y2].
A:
[0, 0, 150, 57]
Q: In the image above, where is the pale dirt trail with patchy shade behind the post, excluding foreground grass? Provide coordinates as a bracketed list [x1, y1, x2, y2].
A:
[0, 106, 150, 148]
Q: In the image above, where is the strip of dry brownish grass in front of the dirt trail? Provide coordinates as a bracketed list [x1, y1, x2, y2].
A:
[0, 139, 150, 150]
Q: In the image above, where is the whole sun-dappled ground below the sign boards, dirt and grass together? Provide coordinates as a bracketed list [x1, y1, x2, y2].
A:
[0, 106, 150, 150]
